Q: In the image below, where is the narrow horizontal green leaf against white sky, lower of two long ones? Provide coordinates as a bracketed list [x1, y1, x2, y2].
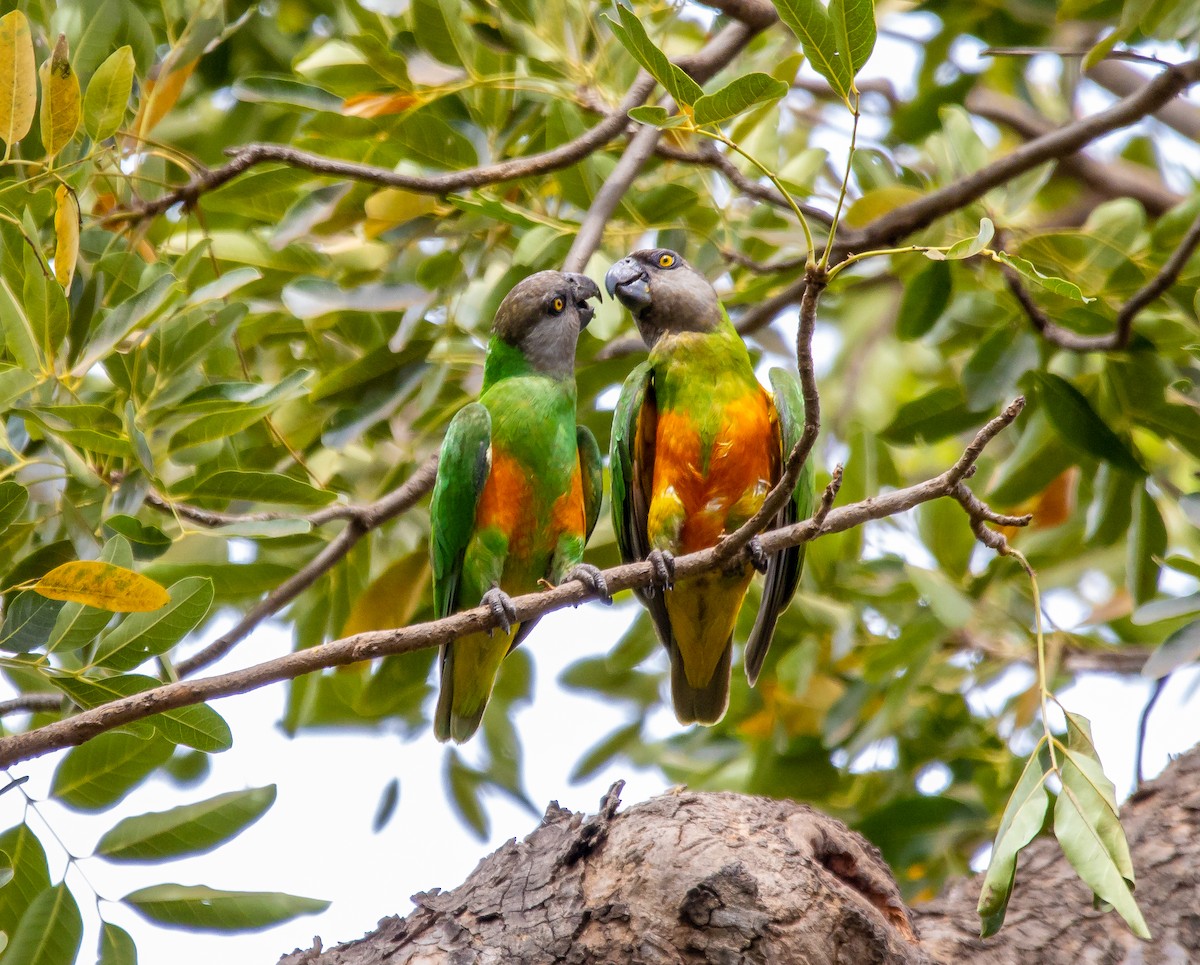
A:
[121, 885, 329, 931]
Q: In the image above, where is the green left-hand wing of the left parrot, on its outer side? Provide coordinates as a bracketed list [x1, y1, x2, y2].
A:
[430, 402, 492, 617]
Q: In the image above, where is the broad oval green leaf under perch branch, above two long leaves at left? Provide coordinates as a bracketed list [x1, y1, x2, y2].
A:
[50, 731, 172, 811]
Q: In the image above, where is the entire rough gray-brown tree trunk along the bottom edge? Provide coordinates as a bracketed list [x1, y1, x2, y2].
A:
[281, 750, 1200, 965]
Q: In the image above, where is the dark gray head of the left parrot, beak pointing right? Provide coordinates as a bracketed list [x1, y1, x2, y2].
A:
[492, 271, 600, 378]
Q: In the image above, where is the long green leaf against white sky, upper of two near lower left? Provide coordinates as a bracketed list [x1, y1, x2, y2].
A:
[96, 784, 275, 862]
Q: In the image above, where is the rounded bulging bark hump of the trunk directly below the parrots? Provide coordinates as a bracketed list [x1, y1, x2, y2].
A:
[283, 783, 930, 965]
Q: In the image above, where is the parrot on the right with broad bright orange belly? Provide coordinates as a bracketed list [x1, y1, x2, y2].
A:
[605, 248, 814, 724]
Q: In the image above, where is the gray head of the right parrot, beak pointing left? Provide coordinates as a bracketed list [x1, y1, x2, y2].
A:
[604, 248, 721, 348]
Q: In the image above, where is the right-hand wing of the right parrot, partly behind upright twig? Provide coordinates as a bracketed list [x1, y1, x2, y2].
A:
[746, 368, 815, 687]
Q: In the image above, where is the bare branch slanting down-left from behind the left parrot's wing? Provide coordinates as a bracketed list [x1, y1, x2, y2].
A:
[175, 456, 438, 677]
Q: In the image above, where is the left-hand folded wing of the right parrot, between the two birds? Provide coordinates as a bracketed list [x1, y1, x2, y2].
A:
[608, 362, 672, 649]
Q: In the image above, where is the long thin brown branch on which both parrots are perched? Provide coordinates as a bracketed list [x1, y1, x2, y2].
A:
[0, 398, 1024, 767]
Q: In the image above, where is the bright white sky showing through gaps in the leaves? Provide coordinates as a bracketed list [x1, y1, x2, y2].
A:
[0, 16, 1200, 965]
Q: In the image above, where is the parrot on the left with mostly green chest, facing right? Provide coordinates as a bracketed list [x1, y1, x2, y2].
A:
[430, 271, 608, 743]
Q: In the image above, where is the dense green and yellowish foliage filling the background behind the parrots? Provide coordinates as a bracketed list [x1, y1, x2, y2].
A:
[0, 0, 1200, 961]
